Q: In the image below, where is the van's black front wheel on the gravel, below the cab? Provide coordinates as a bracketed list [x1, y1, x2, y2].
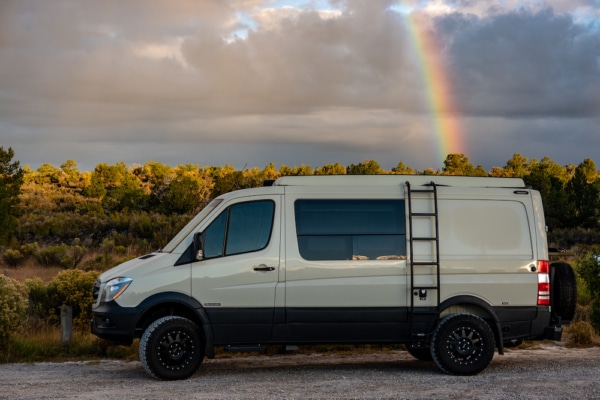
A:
[140, 316, 204, 380]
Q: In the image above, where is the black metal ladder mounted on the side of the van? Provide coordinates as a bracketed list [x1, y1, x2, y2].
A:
[406, 181, 440, 347]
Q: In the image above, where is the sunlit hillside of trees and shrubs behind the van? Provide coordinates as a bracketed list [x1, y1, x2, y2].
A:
[0, 147, 600, 356]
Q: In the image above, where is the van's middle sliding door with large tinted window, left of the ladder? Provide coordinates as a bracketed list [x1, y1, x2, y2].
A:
[285, 196, 407, 342]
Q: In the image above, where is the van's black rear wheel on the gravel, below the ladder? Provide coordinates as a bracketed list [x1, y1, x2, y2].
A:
[431, 314, 495, 375]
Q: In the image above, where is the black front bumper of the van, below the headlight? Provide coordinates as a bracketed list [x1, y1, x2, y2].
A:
[91, 301, 140, 346]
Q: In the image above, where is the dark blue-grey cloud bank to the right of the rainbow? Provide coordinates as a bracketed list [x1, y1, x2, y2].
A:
[438, 9, 600, 118]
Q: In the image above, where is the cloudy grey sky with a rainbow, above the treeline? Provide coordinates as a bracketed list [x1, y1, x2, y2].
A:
[0, 0, 600, 171]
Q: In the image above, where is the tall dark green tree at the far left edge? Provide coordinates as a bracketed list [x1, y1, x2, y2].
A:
[0, 146, 24, 244]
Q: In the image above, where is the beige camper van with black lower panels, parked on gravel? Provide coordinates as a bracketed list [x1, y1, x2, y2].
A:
[91, 175, 576, 380]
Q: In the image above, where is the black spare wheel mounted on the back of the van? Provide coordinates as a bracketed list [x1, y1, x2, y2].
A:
[550, 262, 577, 321]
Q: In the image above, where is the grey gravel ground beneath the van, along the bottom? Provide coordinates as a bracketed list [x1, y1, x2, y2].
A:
[0, 342, 600, 400]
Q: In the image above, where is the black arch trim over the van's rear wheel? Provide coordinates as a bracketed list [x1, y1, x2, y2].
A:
[439, 295, 504, 354]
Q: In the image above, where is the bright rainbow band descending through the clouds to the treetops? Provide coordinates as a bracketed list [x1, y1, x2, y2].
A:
[400, 1, 466, 165]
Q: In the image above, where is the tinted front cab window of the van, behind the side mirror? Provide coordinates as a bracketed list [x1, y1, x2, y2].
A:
[204, 200, 275, 258]
